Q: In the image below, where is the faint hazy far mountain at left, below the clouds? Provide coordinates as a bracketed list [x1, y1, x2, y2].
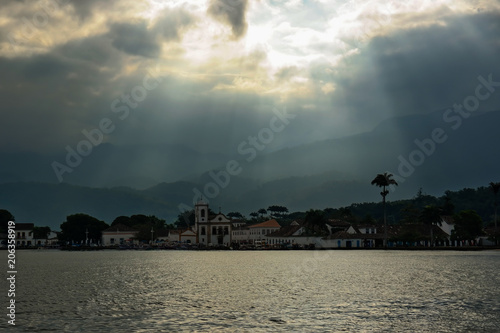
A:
[0, 143, 233, 189]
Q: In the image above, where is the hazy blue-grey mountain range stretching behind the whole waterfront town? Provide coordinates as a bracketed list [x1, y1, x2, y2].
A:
[0, 110, 500, 229]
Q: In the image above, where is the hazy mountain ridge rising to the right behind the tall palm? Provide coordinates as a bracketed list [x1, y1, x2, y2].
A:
[226, 111, 500, 201]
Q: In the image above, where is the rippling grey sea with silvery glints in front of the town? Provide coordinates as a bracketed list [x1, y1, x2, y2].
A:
[0, 250, 500, 332]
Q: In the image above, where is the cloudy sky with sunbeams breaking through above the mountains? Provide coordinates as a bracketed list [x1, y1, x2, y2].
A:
[0, 0, 500, 154]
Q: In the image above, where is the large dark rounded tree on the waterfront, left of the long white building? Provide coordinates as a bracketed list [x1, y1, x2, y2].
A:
[60, 214, 109, 242]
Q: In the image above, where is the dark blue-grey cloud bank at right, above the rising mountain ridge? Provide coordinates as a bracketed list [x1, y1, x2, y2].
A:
[322, 13, 500, 128]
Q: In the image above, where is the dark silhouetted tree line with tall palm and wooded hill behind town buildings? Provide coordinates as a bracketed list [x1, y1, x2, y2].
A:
[0, 180, 500, 242]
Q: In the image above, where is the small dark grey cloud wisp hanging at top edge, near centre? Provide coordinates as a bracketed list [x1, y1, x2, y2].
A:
[208, 0, 248, 39]
